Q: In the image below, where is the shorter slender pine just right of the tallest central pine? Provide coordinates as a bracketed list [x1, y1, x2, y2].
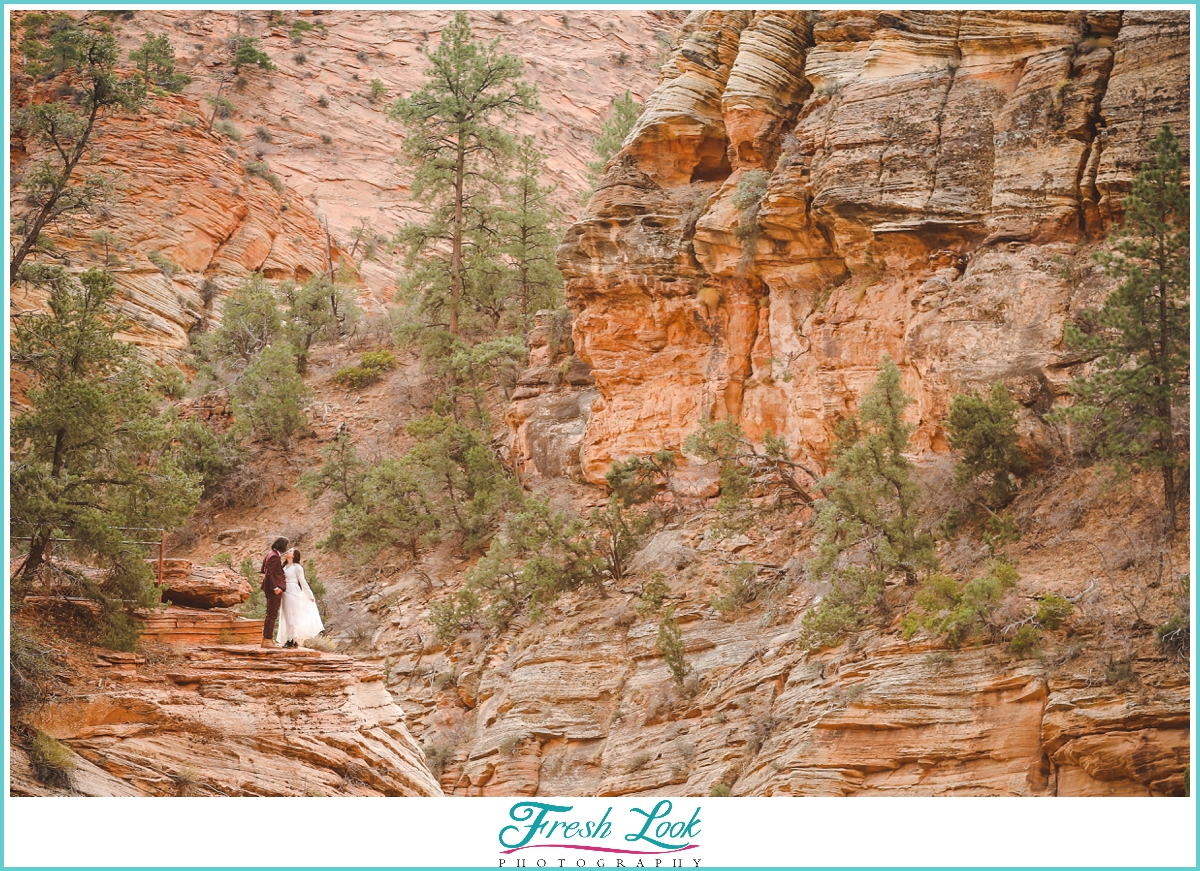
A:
[503, 136, 563, 335]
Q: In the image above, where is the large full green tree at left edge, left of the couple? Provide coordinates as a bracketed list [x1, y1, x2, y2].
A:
[10, 268, 200, 607]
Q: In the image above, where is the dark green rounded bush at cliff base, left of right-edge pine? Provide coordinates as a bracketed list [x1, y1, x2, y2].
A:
[946, 382, 1030, 507]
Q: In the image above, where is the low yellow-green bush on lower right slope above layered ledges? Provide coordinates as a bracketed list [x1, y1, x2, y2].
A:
[900, 559, 1020, 647]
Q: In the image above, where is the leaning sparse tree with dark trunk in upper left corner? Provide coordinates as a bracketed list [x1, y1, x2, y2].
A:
[8, 27, 145, 281]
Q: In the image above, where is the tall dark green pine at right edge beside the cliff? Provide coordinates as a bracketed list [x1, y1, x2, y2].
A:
[1063, 125, 1192, 530]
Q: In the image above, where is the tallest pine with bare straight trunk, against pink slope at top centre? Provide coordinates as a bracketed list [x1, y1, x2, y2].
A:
[388, 12, 538, 337]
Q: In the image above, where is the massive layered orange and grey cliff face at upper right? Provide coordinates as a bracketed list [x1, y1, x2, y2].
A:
[559, 11, 1189, 483]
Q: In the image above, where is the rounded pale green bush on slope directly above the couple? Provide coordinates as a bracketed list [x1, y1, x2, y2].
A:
[232, 342, 312, 446]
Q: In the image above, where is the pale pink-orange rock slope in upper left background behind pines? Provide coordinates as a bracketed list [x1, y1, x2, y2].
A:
[11, 10, 679, 360]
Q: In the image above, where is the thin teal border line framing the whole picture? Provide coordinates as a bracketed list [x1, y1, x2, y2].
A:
[0, 0, 1200, 871]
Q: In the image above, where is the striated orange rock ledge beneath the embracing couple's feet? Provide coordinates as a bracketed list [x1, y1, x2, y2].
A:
[12, 645, 440, 795]
